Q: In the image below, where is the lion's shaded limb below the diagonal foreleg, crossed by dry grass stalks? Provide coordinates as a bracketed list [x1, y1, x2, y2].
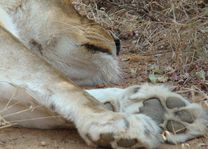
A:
[0, 82, 74, 129]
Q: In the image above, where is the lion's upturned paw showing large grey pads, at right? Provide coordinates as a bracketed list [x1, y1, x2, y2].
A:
[119, 84, 208, 143]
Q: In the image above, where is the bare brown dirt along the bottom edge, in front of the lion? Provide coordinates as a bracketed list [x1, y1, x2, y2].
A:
[0, 128, 208, 149]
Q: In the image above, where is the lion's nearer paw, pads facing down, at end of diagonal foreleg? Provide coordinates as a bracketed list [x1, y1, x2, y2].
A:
[78, 112, 162, 149]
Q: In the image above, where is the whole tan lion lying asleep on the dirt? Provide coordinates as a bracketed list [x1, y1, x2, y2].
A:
[0, 0, 208, 149]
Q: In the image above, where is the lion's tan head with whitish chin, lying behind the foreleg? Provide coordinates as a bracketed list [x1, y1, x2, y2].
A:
[0, 0, 120, 85]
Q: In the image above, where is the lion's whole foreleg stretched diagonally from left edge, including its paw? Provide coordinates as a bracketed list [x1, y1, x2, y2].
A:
[0, 28, 160, 148]
